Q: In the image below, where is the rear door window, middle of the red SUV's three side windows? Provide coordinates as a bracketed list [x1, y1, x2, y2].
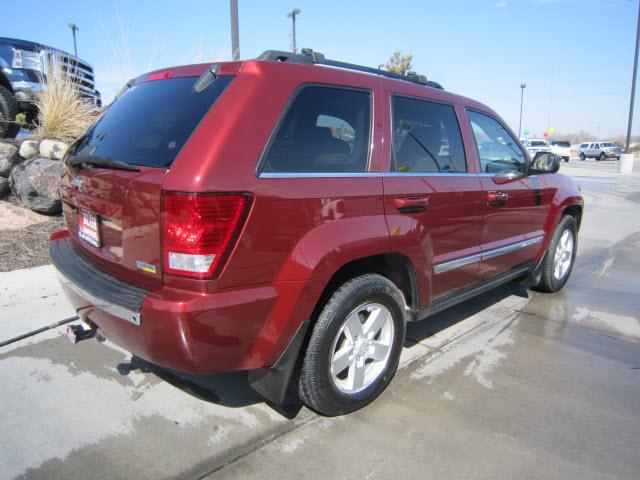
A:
[391, 96, 467, 173]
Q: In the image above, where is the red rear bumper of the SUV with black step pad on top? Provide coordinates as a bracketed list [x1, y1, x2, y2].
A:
[50, 236, 323, 373]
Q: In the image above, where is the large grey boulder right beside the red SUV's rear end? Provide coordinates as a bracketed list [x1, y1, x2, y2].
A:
[9, 157, 62, 215]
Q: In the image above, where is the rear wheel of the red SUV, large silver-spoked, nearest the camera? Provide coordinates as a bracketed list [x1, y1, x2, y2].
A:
[297, 274, 405, 416]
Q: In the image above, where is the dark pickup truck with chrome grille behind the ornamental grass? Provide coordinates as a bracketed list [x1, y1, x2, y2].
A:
[0, 37, 101, 138]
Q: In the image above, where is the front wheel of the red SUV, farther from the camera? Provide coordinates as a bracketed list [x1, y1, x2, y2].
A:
[536, 215, 578, 293]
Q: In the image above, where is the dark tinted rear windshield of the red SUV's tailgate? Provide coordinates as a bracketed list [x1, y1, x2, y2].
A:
[70, 77, 232, 167]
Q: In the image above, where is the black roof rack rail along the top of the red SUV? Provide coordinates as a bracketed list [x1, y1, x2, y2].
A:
[256, 48, 444, 90]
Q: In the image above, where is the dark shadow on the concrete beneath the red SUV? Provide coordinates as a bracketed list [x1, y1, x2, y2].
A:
[118, 284, 529, 419]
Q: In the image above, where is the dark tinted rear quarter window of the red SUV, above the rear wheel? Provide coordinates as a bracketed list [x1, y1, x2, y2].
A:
[263, 86, 371, 173]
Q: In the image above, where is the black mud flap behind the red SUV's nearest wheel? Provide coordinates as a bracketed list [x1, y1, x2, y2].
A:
[249, 320, 309, 404]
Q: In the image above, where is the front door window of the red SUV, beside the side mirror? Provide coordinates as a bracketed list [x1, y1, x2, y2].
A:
[468, 111, 526, 173]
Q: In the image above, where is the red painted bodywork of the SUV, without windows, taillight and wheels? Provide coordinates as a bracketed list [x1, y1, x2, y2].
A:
[52, 57, 582, 373]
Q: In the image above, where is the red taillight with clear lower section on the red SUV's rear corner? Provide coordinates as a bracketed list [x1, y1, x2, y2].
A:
[162, 193, 249, 278]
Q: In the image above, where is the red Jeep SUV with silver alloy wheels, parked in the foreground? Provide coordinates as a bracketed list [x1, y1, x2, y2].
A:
[50, 51, 583, 415]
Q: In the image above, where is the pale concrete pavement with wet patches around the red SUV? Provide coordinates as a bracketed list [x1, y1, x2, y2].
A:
[0, 160, 640, 479]
